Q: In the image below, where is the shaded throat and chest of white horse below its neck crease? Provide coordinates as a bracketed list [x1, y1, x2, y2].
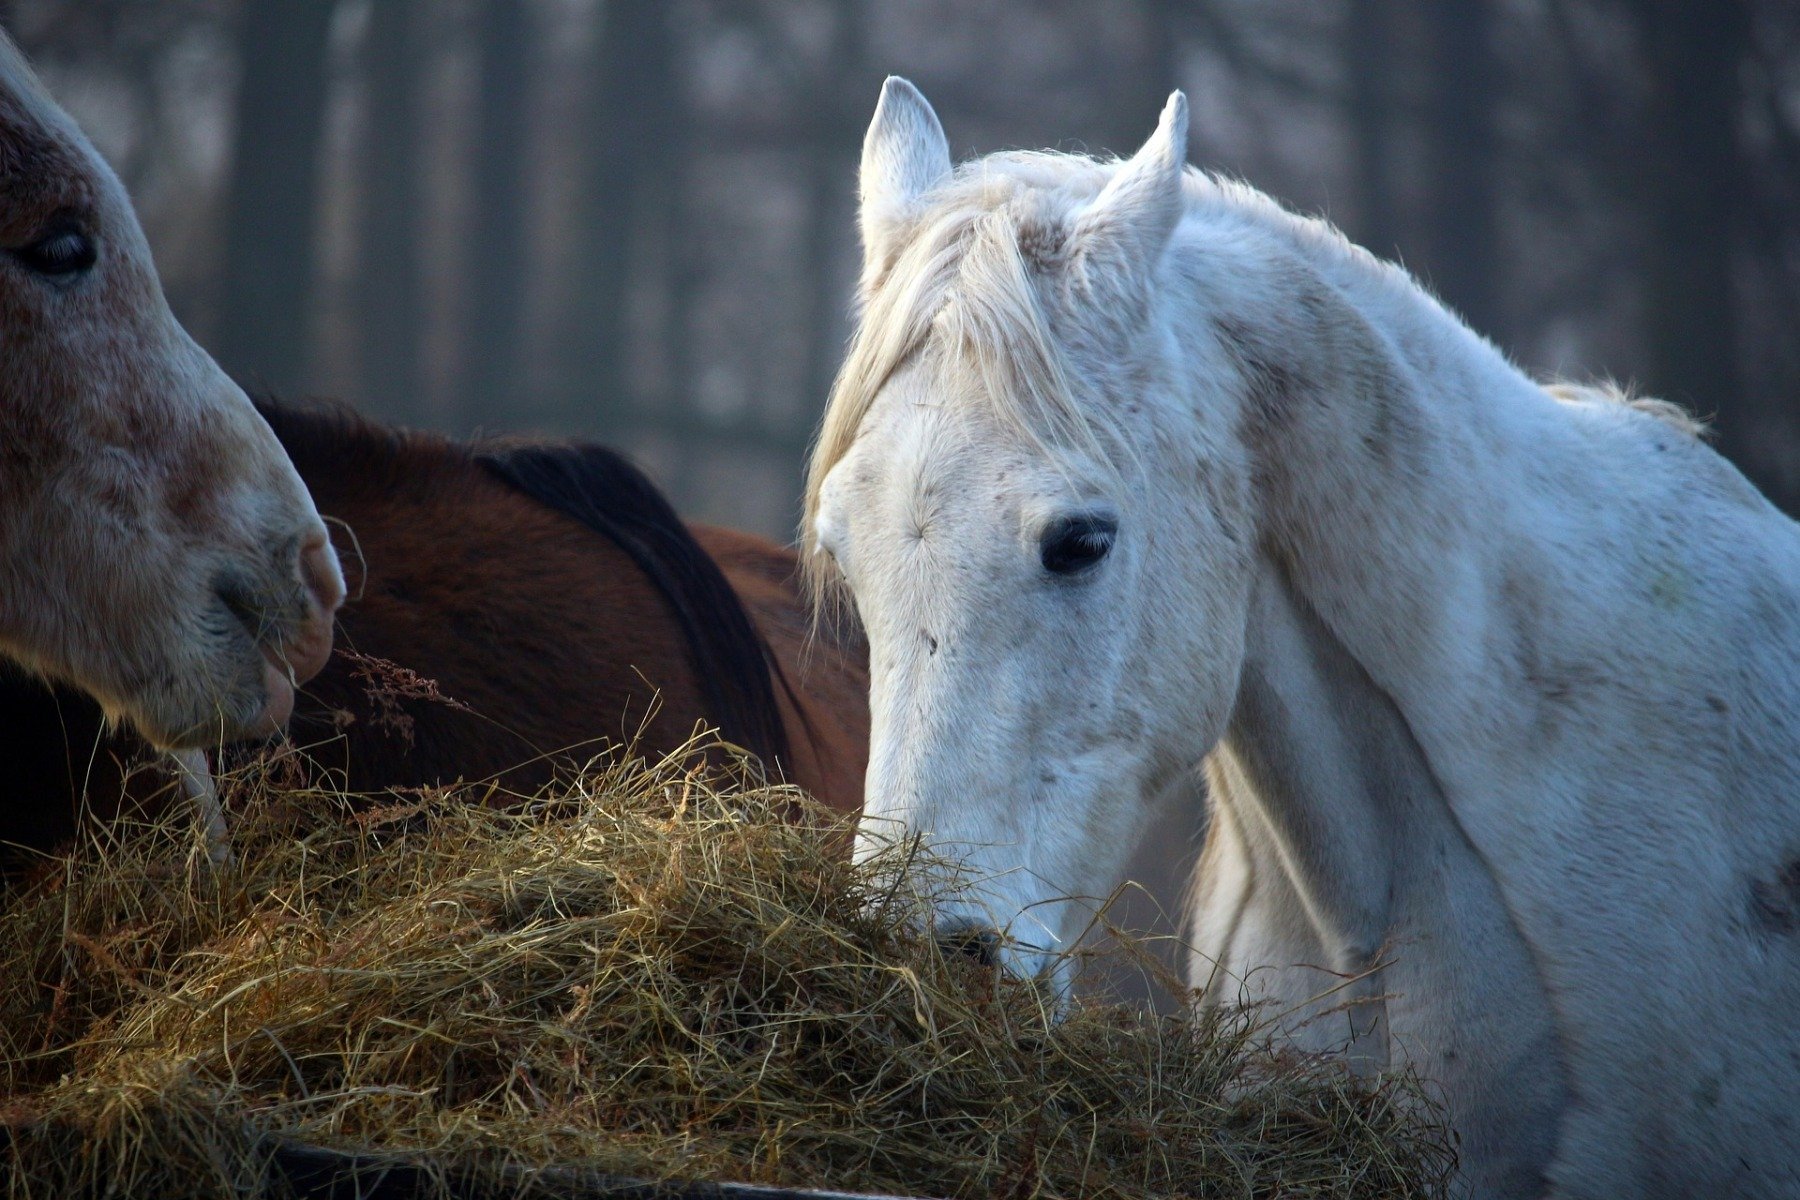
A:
[1190, 561, 1566, 1195]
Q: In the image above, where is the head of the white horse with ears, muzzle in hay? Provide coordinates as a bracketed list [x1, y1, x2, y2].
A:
[803, 79, 1255, 970]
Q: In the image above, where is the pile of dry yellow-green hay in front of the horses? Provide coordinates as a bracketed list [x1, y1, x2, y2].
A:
[0, 744, 1453, 1198]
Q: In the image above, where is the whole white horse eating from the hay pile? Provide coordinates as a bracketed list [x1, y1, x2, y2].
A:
[803, 79, 1800, 1198]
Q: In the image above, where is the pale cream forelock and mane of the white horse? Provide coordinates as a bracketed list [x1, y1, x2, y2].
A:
[801, 151, 1703, 597]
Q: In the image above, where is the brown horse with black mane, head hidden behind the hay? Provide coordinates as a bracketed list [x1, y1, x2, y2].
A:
[0, 403, 868, 874]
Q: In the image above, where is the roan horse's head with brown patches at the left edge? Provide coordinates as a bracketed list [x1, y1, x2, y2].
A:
[0, 36, 344, 747]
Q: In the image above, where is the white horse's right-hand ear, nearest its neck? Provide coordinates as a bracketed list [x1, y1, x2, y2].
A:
[1073, 92, 1188, 279]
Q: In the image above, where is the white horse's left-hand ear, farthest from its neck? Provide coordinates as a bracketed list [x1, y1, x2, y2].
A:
[859, 76, 950, 284]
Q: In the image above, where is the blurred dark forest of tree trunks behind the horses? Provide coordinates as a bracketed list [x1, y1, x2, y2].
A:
[0, 0, 1800, 538]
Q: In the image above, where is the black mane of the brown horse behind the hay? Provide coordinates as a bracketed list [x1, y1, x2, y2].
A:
[256, 396, 792, 768]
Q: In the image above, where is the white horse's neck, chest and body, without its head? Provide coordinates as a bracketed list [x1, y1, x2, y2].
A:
[1166, 188, 1800, 1195]
